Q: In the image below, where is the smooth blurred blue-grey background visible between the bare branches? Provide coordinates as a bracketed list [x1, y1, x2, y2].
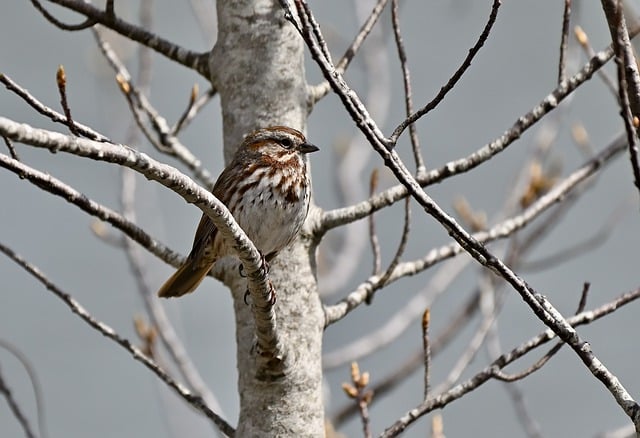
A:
[0, 0, 640, 438]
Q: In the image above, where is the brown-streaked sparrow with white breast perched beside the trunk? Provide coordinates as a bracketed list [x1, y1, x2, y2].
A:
[158, 126, 318, 298]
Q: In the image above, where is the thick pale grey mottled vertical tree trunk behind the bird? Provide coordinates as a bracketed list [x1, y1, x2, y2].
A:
[210, 0, 324, 437]
